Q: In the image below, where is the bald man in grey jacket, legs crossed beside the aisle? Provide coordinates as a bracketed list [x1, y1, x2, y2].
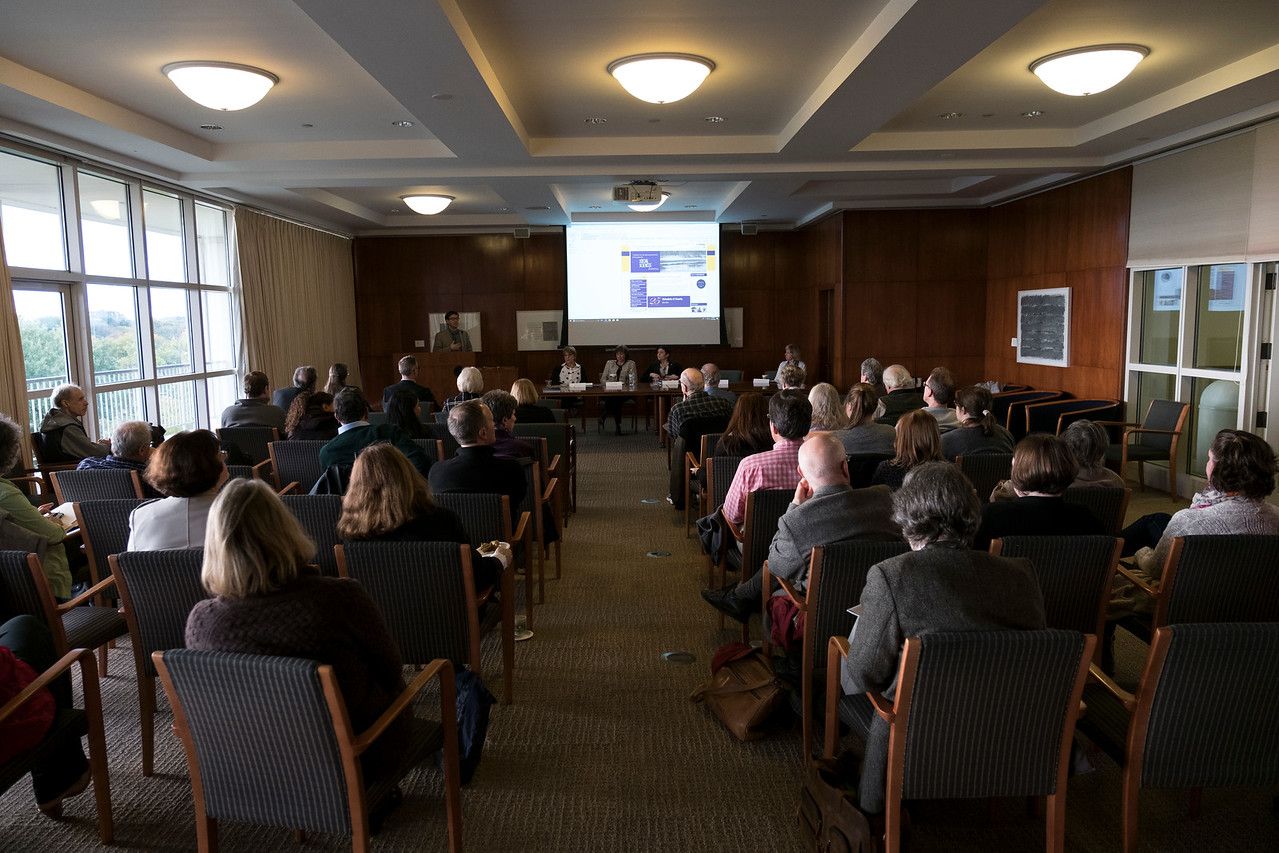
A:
[702, 432, 902, 622]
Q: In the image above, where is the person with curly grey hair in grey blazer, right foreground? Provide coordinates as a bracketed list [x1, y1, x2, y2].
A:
[840, 460, 1045, 813]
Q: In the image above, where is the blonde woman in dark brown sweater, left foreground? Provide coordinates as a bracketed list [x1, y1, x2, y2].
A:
[185, 480, 411, 782]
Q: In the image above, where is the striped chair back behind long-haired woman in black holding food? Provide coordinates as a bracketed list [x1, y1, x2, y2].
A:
[339, 542, 480, 673]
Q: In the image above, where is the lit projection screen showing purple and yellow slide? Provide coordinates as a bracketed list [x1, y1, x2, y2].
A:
[567, 223, 720, 345]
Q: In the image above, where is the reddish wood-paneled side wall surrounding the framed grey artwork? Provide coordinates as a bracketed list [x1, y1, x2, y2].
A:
[986, 169, 1132, 399]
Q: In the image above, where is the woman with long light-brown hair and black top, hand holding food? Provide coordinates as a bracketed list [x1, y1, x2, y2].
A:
[338, 444, 510, 592]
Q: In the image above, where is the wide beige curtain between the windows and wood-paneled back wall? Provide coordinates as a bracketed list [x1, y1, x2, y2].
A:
[235, 208, 361, 396]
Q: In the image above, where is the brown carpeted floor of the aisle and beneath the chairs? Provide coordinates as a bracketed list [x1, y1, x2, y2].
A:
[0, 423, 1279, 853]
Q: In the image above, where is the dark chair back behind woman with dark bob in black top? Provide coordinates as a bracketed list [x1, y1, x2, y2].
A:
[990, 536, 1123, 644]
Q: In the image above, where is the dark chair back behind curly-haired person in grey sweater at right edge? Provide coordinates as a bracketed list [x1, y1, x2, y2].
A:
[1154, 533, 1279, 627]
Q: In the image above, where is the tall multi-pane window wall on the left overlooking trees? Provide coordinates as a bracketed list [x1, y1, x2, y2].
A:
[0, 142, 239, 437]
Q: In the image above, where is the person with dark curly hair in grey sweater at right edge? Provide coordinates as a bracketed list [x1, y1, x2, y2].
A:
[1109, 430, 1279, 619]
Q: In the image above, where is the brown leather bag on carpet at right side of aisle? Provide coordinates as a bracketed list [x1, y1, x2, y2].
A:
[689, 643, 785, 740]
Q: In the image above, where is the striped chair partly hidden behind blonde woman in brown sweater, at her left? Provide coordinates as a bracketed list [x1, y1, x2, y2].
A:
[110, 549, 208, 776]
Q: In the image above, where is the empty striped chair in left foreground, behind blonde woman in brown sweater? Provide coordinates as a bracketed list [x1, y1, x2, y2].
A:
[152, 648, 462, 853]
